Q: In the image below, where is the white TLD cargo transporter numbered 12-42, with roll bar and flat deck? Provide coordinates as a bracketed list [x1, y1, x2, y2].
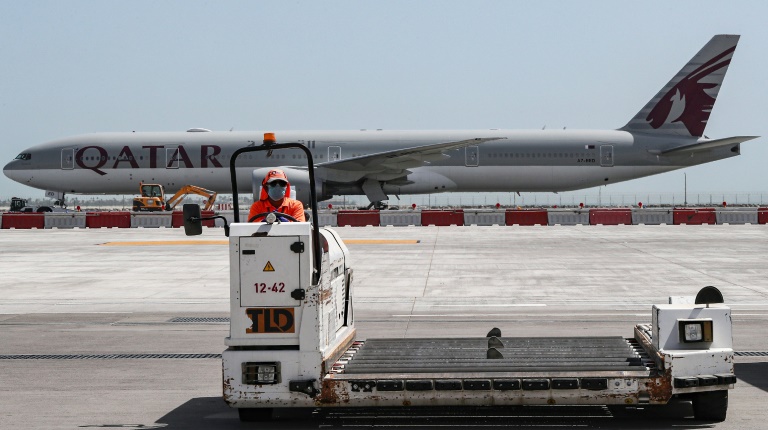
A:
[185, 135, 736, 421]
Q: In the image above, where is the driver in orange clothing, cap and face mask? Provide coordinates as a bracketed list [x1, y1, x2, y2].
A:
[248, 169, 304, 222]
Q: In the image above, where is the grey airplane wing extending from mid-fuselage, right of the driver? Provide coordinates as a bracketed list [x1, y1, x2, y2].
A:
[316, 137, 504, 182]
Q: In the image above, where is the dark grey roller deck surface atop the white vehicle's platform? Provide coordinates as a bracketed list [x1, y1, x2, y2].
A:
[332, 337, 656, 378]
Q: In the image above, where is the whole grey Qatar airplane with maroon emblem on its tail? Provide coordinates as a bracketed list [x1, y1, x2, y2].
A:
[3, 35, 758, 207]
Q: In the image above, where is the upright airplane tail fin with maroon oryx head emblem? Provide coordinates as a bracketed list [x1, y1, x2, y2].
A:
[621, 34, 739, 137]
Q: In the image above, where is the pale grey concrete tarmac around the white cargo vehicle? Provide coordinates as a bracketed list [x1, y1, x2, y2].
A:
[0, 225, 768, 429]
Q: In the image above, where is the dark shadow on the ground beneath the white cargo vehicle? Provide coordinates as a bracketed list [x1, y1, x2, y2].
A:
[152, 397, 728, 429]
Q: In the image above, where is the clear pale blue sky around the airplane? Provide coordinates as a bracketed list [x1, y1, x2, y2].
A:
[0, 0, 768, 204]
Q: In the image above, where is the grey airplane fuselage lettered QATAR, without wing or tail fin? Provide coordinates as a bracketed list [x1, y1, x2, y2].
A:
[4, 130, 739, 199]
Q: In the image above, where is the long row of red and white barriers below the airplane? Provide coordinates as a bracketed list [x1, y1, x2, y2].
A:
[0, 207, 768, 229]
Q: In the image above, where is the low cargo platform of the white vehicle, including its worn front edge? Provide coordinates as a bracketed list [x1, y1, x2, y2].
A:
[320, 336, 658, 406]
